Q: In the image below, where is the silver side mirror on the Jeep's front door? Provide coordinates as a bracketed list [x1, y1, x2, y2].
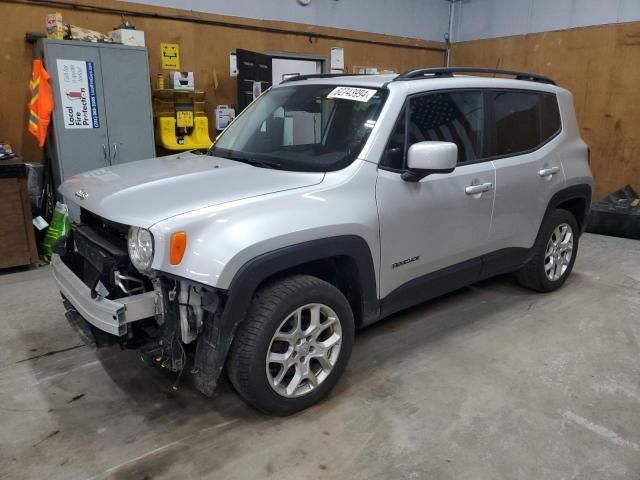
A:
[402, 142, 458, 182]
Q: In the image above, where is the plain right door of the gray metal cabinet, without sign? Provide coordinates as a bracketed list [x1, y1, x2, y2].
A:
[100, 46, 155, 165]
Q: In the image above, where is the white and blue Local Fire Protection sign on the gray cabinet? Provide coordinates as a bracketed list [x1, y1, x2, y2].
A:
[57, 59, 100, 128]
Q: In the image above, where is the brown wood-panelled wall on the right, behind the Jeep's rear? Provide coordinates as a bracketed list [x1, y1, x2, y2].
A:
[452, 22, 640, 197]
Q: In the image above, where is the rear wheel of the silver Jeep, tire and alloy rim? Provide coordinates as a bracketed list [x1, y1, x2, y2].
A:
[516, 209, 580, 293]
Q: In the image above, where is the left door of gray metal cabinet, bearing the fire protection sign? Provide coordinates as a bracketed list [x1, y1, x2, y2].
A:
[42, 40, 109, 185]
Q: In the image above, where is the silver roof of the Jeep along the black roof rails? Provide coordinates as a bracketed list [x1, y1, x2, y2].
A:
[274, 74, 561, 93]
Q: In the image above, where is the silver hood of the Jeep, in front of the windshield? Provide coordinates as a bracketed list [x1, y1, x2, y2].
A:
[59, 153, 324, 227]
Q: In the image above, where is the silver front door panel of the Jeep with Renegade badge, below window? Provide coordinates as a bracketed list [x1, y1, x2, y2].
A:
[376, 162, 495, 297]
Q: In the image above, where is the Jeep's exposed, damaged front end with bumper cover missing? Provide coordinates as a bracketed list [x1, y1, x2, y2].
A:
[51, 219, 235, 395]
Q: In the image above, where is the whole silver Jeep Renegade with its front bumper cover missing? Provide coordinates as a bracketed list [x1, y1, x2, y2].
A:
[53, 68, 593, 415]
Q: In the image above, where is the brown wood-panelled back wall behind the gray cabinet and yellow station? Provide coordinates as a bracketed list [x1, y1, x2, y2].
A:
[0, 0, 444, 161]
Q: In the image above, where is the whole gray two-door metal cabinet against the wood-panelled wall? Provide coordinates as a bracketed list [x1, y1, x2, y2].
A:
[38, 40, 155, 188]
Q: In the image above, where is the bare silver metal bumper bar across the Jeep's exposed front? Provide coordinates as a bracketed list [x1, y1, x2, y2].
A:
[51, 255, 163, 337]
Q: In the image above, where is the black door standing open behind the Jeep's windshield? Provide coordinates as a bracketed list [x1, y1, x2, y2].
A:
[236, 50, 272, 112]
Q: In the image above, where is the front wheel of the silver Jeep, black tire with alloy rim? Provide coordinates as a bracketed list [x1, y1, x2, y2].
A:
[227, 275, 355, 416]
